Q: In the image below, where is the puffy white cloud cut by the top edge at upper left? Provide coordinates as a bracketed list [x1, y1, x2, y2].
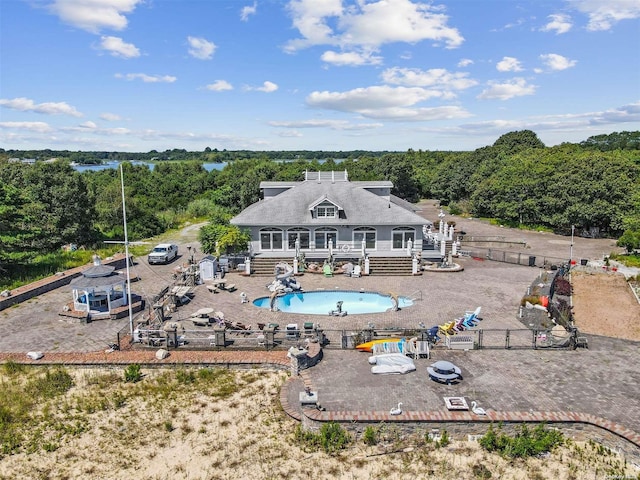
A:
[47, 0, 142, 33]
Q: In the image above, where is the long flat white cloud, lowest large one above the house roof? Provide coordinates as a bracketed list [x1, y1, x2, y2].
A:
[306, 85, 469, 121]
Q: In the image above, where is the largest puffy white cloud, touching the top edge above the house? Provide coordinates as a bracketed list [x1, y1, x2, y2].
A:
[285, 0, 464, 52]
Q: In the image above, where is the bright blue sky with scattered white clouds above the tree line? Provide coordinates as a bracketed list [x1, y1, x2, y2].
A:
[0, 0, 640, 152]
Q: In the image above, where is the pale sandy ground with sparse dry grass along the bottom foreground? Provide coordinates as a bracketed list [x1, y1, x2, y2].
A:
[0, 369, 640, 480]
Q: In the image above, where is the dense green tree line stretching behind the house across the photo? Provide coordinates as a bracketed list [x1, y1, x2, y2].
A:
[0, 130, 640, 284]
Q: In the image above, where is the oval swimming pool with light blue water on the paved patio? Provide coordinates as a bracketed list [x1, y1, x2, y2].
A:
[253, 290, 413, 315]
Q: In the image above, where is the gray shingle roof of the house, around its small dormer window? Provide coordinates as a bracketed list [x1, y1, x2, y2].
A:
[231, 181, 429, 226]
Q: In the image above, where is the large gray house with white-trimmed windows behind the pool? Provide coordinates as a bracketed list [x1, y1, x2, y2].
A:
[231, 171, 432, 270]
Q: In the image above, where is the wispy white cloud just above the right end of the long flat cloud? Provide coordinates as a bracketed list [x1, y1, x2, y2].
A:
[382, 67, 478, 91]
